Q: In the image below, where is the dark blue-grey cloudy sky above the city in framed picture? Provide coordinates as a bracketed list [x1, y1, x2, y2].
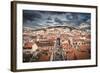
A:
[23, 10, 91, 28]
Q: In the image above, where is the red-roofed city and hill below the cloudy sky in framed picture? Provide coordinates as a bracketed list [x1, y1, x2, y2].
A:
[23, 25, 91, 62]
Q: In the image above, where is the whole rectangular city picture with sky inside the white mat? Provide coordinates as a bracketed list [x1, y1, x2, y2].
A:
[23, 10, 91, 62]
